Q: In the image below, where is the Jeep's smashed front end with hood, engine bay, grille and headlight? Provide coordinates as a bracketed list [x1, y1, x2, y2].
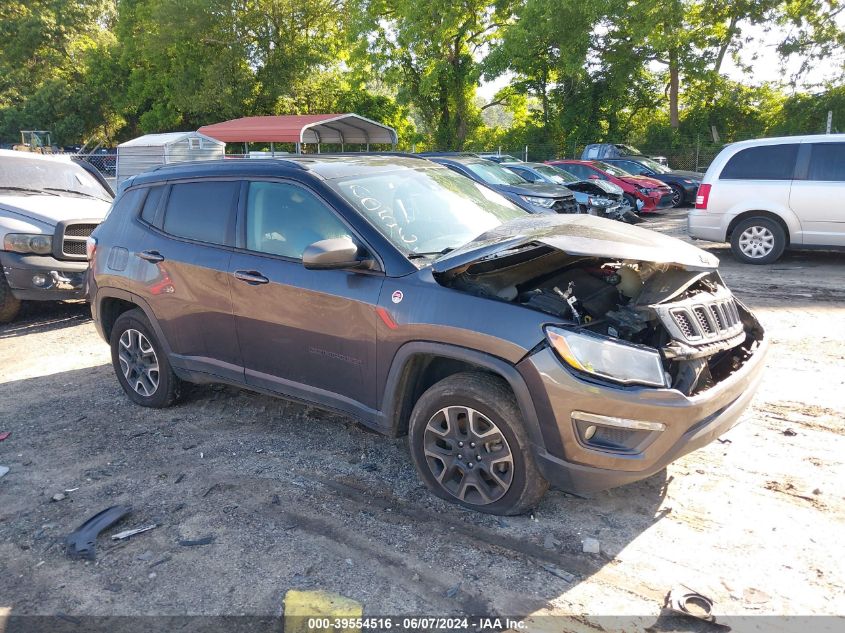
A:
[435, 216, 763, 396]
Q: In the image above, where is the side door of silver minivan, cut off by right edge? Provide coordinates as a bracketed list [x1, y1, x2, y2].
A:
[789, 141, 845, 246]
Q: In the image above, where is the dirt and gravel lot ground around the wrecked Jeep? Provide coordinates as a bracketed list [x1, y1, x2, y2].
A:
[0, 211, 845, 630]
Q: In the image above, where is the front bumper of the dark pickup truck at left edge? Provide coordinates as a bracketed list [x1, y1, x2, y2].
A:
[0, 251, 88, 301]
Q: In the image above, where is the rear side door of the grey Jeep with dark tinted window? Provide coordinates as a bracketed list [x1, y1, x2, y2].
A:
[133, 180, 243, 381]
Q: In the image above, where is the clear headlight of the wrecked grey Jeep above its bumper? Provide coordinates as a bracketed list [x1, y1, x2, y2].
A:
[546, 327, 669, 387]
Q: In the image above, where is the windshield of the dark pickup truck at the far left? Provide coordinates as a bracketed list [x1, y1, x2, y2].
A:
[0, 156, 112, 202]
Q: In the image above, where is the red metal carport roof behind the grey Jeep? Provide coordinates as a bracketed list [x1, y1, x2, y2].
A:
[197, 114, 397, 144]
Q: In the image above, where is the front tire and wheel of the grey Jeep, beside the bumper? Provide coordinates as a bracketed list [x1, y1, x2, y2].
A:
[408, 372, 549, 515]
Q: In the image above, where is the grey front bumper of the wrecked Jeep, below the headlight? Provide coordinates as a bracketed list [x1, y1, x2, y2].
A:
[517, 330, 769, 494]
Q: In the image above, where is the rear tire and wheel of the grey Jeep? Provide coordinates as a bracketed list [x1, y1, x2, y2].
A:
[110, 308, 182, 409]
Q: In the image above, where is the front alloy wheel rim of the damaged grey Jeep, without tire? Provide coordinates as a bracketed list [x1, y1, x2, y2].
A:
[423, 406, 514, 505]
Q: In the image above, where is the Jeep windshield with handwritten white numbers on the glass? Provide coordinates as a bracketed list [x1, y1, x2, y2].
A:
[328, 168, 527, 256]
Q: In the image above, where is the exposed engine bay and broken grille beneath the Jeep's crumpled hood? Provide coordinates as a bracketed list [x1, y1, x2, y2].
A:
[439, 243, 763, 395]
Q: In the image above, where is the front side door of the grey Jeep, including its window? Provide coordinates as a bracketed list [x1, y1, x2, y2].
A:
[224, 181, 384, 414]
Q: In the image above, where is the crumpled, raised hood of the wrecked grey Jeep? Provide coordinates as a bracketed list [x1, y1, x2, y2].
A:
[432, 214, 719, 273]
